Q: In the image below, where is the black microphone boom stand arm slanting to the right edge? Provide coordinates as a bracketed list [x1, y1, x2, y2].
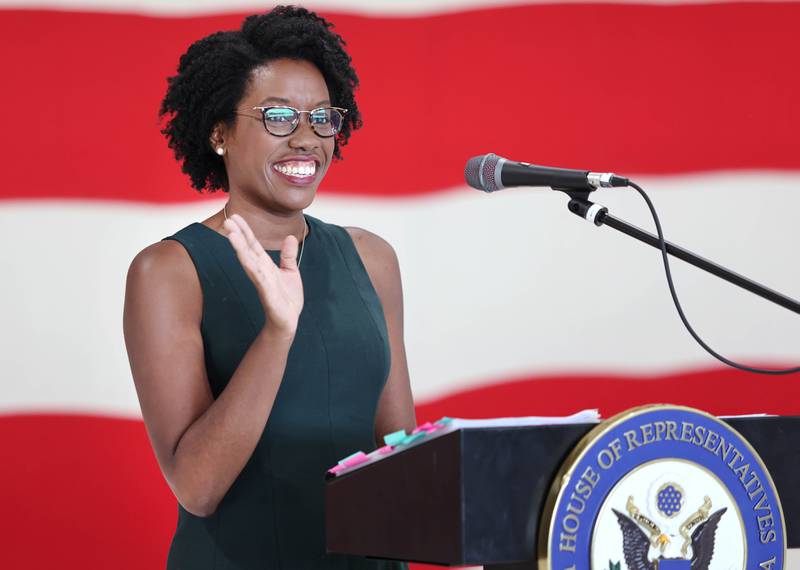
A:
[564, 188, 800, 314]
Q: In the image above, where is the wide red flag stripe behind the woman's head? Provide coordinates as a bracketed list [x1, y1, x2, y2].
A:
[0, 3, 800, 202]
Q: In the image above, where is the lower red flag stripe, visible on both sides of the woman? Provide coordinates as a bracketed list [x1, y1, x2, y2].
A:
[0, 369, 800, 570]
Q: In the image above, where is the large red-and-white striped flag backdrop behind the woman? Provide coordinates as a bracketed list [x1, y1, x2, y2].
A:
[0, 0, 800, 570]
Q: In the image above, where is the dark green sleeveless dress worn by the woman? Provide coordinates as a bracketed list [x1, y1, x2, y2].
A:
[167, 216, 406, 570]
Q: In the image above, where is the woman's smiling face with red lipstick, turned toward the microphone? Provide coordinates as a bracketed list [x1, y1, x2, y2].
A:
[211, 59, 334, 214]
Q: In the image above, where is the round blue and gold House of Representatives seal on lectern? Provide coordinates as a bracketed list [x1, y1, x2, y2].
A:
[539, 405, 786, 570]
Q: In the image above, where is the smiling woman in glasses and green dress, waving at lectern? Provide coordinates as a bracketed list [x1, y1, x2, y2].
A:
[124, 7, 415, 570]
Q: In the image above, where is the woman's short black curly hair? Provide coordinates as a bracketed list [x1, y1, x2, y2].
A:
[159, 6, 361, 192]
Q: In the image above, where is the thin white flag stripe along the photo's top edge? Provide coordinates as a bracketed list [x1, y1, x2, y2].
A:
[0, 0, 796, 16]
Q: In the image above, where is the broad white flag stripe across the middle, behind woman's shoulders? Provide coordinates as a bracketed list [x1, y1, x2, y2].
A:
[0, 173, 800, 416]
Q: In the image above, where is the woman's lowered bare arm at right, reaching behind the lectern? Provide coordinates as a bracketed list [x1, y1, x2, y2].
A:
[345, 227, 416, 442]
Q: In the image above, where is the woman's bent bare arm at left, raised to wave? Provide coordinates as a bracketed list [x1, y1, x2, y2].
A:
[124, 215, 302, 516]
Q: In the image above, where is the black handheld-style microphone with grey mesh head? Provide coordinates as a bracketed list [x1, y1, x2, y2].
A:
[464, 153, 628, 192]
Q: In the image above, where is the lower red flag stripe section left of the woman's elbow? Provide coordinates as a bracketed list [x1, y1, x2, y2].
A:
[0, 415, 177, 570]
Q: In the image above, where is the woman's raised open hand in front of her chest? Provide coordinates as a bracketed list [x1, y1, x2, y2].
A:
[223, 214, 303, 335]
